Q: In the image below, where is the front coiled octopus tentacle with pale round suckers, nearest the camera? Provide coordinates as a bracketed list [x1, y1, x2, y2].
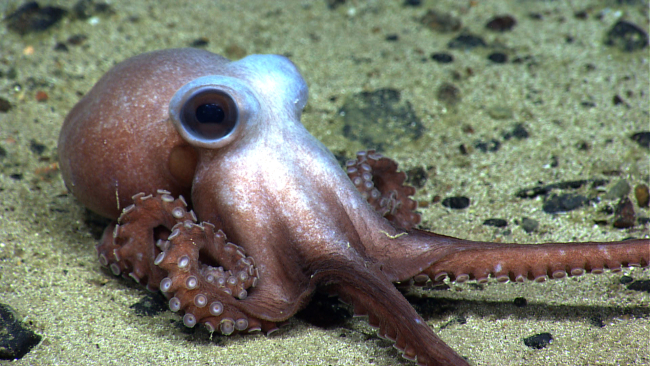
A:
[155, 220, 268, 335]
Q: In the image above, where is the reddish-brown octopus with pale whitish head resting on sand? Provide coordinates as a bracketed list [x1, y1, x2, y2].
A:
[58, 49, 650, 366]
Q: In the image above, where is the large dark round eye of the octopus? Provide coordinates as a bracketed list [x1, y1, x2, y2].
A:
[179, 88, 239, 142]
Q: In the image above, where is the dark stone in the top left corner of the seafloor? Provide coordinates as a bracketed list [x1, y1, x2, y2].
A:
[5, 1, 68, 36]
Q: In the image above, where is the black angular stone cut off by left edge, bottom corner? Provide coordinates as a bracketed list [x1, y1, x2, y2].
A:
[0, 304, 41, 360]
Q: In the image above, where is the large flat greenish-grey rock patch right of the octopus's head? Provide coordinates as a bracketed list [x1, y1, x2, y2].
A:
[338, 88, 424, 151]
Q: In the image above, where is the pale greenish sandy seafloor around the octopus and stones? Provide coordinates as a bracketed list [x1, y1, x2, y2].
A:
[0, 0, 650, 365]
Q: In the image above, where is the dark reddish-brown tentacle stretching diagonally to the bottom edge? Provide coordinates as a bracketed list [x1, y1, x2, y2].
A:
[313, 266, 469, 366]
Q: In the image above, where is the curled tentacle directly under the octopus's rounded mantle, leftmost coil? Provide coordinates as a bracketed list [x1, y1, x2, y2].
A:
[96, 190, 196, 291]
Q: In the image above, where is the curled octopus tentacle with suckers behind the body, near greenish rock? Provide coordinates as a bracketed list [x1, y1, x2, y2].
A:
[346, 150, 420, 229]
